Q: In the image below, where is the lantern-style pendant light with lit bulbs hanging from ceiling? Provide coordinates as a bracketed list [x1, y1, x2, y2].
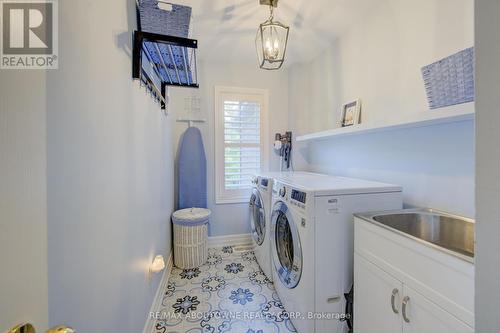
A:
[255, 0, 289, 70]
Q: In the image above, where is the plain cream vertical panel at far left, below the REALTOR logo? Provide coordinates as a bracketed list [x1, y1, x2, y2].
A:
[0, 70, 48, 332]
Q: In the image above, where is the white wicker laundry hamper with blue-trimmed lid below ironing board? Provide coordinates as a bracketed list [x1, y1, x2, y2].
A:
[172, 208, 211, 269]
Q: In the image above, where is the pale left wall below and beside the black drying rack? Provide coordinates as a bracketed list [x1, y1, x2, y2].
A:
[47, 0, 174, 333]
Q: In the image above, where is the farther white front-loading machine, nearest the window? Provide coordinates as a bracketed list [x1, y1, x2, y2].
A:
[250, 171, 322, 281]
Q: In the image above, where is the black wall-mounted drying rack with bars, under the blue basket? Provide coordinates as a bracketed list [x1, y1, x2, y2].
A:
[132, 31, 199, 110]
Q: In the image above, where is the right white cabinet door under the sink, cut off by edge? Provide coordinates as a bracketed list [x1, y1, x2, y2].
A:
[401, 285, 474, 333]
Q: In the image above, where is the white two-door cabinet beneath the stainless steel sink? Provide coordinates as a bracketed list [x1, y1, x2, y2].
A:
[354, 218, 474, 333]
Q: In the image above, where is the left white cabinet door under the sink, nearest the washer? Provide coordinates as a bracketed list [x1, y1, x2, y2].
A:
[353, 254, 402, 333]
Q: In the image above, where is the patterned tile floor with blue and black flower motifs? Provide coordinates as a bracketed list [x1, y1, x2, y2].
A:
[154, 246, 295, 333]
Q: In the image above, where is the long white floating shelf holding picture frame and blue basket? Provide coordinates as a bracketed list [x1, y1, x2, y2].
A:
[296, 103, 475, 142]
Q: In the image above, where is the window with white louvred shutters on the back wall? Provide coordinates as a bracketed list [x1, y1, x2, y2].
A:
[215, 87, 268, 203]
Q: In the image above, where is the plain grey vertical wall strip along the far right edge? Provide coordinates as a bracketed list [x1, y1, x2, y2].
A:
[475, 0, 500, 333]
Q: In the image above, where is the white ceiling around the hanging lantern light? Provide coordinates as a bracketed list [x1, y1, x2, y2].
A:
[172, 0, 381, 66]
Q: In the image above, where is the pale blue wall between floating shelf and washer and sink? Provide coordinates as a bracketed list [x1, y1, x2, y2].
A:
[296, 121, 475, 217]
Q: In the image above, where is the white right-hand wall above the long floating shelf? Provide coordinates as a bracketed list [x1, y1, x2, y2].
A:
[290, 0, 474, 133]
